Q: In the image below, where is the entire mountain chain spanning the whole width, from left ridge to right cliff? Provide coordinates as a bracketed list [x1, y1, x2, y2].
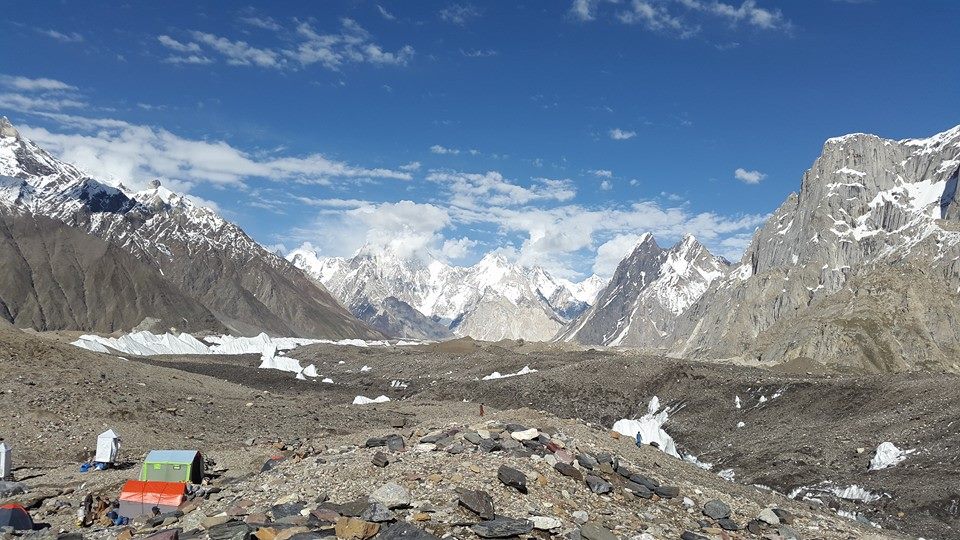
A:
[0, 110, 960, 371]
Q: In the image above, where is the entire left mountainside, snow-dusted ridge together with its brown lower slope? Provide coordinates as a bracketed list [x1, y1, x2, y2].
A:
[0, 118, 382, 338]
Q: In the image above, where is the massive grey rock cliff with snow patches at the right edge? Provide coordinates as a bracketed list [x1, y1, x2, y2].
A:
[668, 126, 960, 371]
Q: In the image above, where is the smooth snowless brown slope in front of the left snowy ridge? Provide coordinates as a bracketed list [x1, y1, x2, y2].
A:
[0, 206, 226, 333]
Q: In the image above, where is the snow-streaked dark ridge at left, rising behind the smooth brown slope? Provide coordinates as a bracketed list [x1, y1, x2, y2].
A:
[0, 120, 381, 338]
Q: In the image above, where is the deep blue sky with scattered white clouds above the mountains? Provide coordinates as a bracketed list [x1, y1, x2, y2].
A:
[0, 0, 960, 278]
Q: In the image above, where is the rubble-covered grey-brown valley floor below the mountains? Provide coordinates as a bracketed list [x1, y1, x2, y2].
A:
[0, 331, 960, 538]
